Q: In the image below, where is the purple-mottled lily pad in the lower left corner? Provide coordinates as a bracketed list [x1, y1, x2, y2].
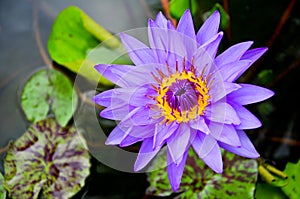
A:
[4, 118, 91, 199]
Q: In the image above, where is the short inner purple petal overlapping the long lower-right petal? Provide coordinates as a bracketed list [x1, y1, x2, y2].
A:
[209, 122, 241, 146]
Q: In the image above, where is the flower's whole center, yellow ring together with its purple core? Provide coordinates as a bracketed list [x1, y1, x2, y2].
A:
[155, 64, 209, 124]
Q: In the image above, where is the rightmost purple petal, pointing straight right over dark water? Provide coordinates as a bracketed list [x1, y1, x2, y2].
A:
[228, 84, 274, 105]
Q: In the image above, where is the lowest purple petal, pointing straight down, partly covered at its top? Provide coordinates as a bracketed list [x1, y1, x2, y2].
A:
[167, 151, 188, 192]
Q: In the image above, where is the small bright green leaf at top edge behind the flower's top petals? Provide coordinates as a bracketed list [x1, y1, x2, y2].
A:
[170, 0, 197, 19]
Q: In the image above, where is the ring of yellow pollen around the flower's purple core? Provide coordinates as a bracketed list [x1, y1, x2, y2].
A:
[153, 67, 210, 124]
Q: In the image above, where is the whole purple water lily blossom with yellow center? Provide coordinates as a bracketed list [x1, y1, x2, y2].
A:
[94, 10, 273, 191]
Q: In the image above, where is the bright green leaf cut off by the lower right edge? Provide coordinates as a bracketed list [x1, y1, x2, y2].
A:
[282, 160, 300, 199]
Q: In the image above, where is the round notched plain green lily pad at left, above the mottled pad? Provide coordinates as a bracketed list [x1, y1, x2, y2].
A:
[21, 69, 78, 126]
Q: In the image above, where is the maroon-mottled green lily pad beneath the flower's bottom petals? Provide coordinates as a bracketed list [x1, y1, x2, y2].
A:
[147, 149, 257, 199]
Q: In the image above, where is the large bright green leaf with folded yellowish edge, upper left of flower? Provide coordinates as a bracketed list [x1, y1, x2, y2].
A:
[48, 6, 129, 85]
